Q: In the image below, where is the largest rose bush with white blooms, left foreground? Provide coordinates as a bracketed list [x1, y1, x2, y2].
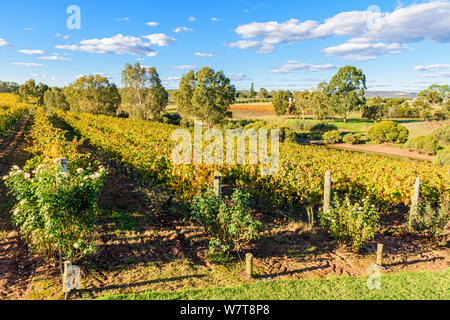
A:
[4, 164, 106, 263]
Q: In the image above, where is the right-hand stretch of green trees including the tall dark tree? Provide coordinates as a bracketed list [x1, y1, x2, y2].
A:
[271, 66, 450, 122]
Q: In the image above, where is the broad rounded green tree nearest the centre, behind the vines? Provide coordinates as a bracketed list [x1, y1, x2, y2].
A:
[174, 67, 236, 127]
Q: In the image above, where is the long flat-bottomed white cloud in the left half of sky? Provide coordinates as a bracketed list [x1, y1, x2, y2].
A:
[56, 34, 157, 57]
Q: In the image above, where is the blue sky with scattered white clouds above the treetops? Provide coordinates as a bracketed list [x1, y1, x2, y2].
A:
[0, 0, 450, 91]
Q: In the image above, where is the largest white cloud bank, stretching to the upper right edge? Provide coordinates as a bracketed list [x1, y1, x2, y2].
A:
[232, 1, 450, 60]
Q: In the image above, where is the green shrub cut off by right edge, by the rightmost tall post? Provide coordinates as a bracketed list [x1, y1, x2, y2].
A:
[408, 194, 450, 244]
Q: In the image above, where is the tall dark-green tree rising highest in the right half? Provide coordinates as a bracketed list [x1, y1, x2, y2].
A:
[327, 66, 367, 122]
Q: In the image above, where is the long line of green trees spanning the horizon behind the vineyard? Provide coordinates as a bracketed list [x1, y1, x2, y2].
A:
[8, 63, 450, 127]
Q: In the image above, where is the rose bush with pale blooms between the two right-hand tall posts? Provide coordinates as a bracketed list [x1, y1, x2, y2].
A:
[319, 198, 379, 251]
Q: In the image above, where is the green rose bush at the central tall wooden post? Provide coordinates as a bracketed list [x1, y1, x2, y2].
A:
[191, 189, 262, 253]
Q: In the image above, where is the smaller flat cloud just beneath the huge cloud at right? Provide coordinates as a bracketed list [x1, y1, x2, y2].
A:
[323, 41, 407, 61]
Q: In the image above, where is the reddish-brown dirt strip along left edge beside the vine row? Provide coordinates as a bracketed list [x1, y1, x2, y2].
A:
[0, 118, 37, 299]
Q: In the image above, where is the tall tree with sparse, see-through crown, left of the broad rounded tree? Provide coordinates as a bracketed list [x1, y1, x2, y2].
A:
[122, 63, 169, 119]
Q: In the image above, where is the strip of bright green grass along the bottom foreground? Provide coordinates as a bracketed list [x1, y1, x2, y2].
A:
[100, 268, 450, 300]
